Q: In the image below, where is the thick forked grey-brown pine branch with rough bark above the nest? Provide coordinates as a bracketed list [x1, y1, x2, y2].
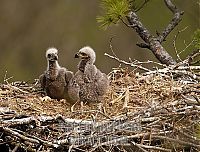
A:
[127, 0, 183, 65]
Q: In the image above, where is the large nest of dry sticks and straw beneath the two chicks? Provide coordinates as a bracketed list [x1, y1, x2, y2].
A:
[0, 67, 200, 152]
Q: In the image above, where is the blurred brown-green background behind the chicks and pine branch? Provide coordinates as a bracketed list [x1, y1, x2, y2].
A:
[0, 0, 200, 82]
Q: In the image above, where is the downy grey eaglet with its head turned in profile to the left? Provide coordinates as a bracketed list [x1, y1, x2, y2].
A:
[68, 46, 109, 103]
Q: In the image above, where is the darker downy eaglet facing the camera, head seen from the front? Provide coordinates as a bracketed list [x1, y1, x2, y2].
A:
[39, 48, 73, 102]
